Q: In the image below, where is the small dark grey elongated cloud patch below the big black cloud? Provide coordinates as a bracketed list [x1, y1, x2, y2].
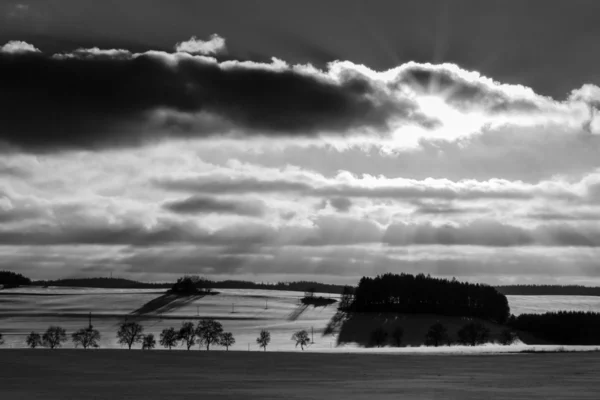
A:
[163, 196, 265, 217]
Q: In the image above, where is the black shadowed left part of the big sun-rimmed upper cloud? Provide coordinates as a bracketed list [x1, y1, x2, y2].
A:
[0, 45, 420, 151]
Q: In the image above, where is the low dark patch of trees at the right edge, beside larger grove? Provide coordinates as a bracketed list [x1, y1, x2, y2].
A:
[508, 311, 600, 345]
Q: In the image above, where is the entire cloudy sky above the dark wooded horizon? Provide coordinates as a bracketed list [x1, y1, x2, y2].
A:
[0, 0, 600, 284]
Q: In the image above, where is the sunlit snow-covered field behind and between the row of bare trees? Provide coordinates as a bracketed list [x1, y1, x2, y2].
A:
[0, 287, 600, 354]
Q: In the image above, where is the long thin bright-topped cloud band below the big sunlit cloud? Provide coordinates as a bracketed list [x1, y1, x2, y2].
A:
[152, 169, 580, 203]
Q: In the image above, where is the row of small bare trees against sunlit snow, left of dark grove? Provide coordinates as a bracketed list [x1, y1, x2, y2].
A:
[0, 318, 318, 351]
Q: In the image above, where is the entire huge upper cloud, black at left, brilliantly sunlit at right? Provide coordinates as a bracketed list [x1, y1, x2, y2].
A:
[0, 35, 597, 152]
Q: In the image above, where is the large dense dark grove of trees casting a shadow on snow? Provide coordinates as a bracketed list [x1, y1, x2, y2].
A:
[348, 273, 510, 323]
